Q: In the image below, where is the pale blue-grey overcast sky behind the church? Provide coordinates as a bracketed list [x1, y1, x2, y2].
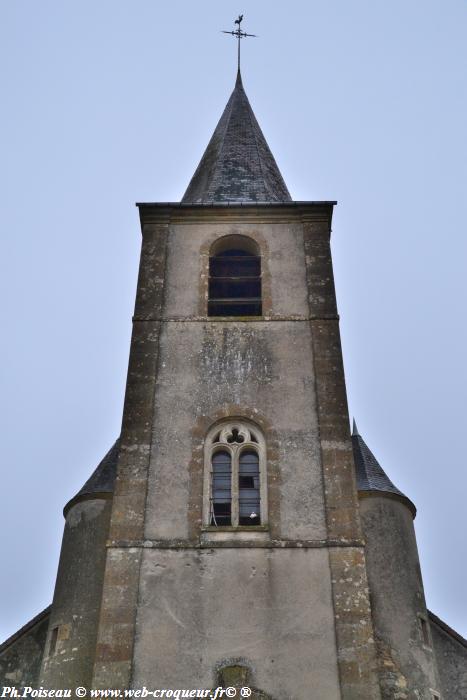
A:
[0, 0, 467, 639]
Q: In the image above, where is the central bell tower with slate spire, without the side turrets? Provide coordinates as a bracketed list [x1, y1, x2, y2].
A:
[88, 67, 380, 700]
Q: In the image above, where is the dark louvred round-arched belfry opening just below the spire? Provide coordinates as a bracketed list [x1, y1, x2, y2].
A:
[208, 235, 262, 316]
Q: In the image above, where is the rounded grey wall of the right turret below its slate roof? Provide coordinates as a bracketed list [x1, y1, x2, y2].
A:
[360, 496, 442, 700]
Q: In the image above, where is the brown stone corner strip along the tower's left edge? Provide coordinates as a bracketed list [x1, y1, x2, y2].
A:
[93, 224, 168, 688]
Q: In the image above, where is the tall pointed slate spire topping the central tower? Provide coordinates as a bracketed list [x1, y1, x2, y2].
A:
[182, 71, 291, 204]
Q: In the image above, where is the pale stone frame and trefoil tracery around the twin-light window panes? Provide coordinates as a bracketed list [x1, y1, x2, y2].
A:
[203, 418, 268, 531]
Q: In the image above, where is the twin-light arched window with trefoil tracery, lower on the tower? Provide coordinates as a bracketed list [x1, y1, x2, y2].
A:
[204, 421, 267, 527]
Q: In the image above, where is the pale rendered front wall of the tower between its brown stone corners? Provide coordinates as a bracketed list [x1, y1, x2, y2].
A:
[133, 212, 339, 698]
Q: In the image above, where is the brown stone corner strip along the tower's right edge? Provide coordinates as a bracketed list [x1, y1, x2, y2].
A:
[303, 219, 381, 700]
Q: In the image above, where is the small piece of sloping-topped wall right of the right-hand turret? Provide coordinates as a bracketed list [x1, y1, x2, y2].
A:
[430, 613, 467, 700]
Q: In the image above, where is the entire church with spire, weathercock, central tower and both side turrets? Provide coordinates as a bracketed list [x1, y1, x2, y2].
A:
[0, 16, 467, 700]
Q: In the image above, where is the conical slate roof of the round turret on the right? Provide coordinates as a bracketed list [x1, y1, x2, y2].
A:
[352, 420, 417, 517]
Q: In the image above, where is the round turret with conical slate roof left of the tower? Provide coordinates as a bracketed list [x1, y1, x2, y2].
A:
[40, 440, 119, 688]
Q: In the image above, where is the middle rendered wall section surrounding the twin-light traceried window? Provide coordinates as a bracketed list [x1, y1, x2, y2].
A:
[145, 321, 326, 539]
